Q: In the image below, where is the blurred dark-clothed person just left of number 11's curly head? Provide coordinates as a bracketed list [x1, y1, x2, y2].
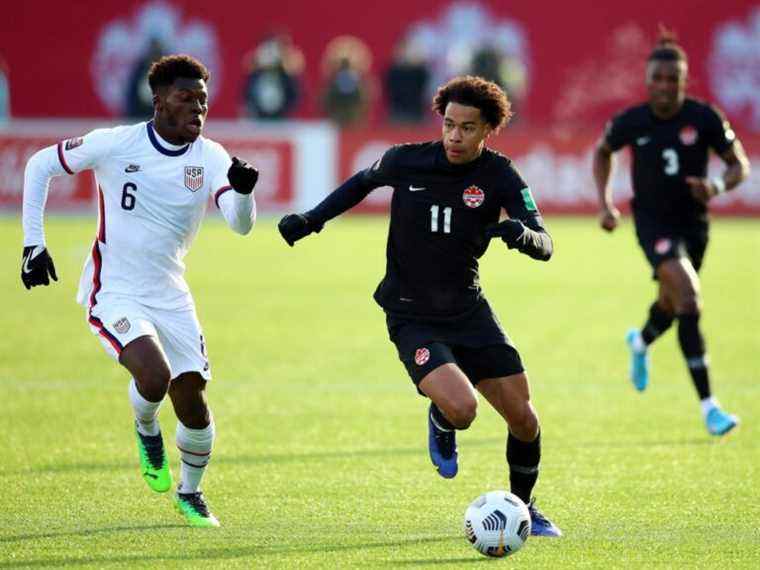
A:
[385, 40, 430, 123]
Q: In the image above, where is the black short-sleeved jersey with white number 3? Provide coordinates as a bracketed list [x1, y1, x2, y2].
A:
[605, 98, 735, 226]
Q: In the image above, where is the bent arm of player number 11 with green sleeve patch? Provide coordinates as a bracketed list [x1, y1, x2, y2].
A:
[486, 165, 554, 261]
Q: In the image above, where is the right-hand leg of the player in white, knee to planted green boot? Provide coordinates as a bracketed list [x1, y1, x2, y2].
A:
[169, 372, 219, 527]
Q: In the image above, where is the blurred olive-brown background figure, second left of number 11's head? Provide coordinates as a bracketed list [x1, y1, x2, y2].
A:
[322, 36, 374, 127]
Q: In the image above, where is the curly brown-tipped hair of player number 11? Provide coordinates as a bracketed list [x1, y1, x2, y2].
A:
[433, 75, 512, 132]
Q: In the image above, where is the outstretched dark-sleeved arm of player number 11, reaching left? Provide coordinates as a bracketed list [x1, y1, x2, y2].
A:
[277, 149, 393, 247]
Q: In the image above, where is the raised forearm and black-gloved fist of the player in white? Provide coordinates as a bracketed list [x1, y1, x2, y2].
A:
[214, 157, 259, 235]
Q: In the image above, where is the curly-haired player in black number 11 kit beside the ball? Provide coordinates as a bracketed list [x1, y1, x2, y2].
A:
[279, 76, 561, 536]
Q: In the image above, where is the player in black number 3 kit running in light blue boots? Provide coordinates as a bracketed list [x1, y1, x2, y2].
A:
[593, 31, 749, 436]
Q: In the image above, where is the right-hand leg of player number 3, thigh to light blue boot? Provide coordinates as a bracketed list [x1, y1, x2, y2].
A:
[657, 250, 738, 436]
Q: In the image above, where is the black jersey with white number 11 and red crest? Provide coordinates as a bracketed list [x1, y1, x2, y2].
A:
[362, 141, 545, 319]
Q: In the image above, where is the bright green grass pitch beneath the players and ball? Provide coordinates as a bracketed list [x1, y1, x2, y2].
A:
[0, 216, 760, 569]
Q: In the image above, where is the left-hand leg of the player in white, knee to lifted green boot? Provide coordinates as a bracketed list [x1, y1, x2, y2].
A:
[119, 335, 172, 493]
